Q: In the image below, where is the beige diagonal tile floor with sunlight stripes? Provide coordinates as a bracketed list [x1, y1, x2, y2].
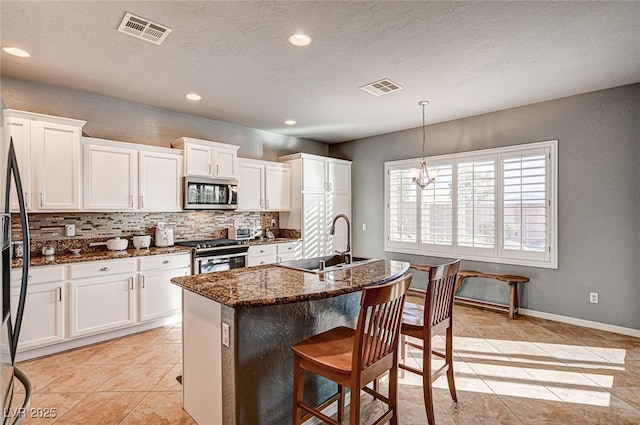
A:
[11, 306, 640, 425]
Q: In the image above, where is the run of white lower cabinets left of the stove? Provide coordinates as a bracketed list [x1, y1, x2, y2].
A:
[11, 252, 191, 352]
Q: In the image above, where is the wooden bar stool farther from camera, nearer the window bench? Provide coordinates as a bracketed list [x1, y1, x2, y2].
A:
[398, 260, 460, 425]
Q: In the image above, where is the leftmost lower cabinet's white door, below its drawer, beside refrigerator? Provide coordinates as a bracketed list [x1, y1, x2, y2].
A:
[11, 282, 65, 351]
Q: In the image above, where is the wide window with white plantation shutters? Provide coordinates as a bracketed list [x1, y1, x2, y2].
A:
[385, 140, 557, 268]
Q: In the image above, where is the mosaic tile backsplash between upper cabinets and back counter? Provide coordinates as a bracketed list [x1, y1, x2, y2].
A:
[11, 211, 300, 252]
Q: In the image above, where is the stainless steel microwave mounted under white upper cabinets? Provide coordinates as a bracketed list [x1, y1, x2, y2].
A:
[183, 176, 238, 210]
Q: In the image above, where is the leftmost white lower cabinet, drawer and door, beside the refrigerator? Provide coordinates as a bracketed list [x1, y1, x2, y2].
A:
[11, 266, 66, 352]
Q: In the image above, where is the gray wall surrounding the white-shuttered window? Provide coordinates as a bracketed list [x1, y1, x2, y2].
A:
[329, 84, 640, 329]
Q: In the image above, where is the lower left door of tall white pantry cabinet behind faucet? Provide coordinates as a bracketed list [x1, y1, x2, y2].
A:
[302, 192, 331, 258]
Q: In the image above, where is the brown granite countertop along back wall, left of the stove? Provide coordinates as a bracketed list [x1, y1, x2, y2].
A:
[11, 246, 191, 268]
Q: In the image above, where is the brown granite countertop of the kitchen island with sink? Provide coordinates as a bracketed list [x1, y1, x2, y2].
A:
[171, 260, 409, 309]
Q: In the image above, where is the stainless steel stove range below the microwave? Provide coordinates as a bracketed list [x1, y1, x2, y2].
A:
[176, 239, 249, 274]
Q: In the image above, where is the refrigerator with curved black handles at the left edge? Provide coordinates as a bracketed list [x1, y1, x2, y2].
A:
[0, 135, 31, 425]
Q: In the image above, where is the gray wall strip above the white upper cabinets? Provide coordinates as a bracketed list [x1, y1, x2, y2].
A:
[1, 77, 328, 161]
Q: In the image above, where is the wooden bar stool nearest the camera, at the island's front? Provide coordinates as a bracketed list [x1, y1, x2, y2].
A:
[293, 274, 412, 425]
